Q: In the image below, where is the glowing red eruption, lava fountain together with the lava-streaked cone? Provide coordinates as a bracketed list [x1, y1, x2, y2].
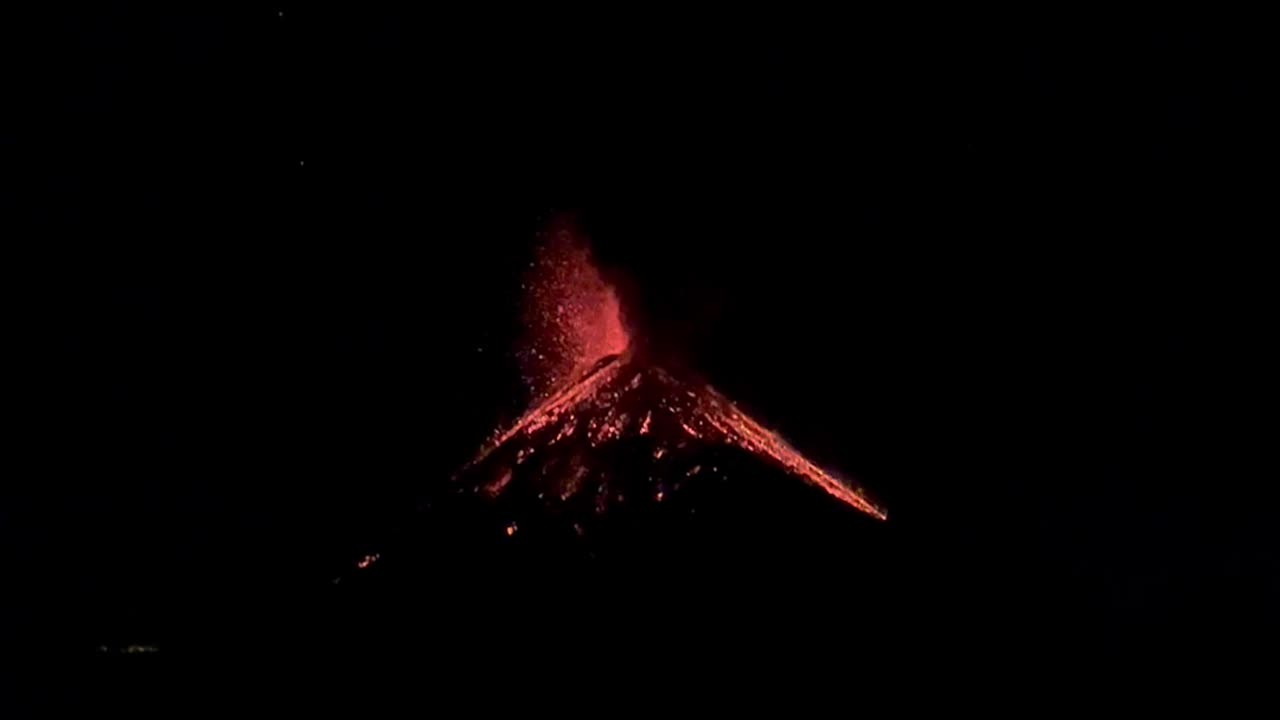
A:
[454, 221, 886, 517]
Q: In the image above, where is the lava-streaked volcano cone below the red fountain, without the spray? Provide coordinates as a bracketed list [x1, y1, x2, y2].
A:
[453, 348, 886, 519]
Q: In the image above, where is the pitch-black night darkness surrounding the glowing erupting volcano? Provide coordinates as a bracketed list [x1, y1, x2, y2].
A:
[0, 6, 1280, 707]
